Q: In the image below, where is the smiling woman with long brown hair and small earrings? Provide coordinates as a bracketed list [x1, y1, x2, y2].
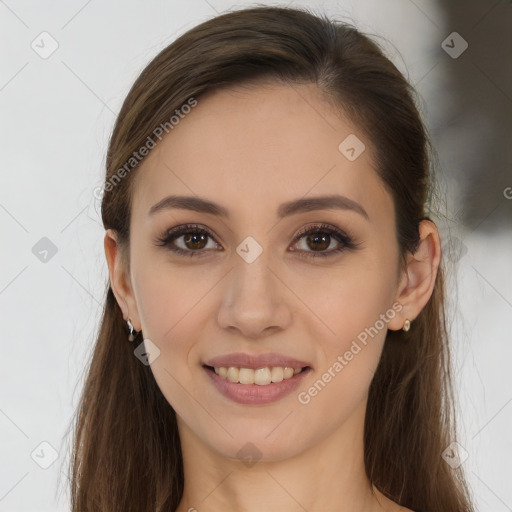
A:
[68, 7, 474, 512]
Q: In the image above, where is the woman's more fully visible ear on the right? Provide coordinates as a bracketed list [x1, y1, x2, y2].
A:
[388, 220, 441, 330]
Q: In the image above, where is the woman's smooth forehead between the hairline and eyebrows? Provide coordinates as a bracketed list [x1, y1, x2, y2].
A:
[132, 84, 392, 226]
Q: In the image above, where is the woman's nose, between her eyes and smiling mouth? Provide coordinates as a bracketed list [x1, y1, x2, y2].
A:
[218, 251, 292, 339]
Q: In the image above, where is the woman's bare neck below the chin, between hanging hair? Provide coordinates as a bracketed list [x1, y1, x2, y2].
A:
[177, 403, 388, 512]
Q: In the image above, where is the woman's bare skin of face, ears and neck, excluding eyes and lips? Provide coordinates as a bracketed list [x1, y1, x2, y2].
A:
[105, 84, 441, 512]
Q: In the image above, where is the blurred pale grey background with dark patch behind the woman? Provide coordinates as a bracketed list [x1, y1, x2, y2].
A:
[0, 0, 512, 512]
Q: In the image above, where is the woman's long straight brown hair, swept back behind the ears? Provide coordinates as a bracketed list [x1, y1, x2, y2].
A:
[70, 7, 474, 512]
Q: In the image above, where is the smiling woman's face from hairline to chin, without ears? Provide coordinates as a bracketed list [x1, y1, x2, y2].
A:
[119, 84, 403, 460]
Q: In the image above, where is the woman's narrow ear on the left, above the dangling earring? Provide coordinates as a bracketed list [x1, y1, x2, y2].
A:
[104, 229, 141, 331]
